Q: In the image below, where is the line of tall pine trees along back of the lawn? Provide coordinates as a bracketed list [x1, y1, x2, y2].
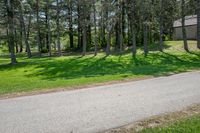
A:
[0, 0, 200, 64]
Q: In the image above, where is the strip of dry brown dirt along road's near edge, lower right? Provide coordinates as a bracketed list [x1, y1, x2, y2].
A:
[102, 104, 200, 133]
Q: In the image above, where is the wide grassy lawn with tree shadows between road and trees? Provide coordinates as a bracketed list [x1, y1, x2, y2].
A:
[0, 42, 200, 95]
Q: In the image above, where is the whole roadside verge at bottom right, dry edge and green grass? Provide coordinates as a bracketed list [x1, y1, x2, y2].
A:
[105, 105, 200, 133]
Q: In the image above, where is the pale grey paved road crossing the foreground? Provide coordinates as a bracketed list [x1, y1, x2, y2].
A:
[0, 72, 200, 133]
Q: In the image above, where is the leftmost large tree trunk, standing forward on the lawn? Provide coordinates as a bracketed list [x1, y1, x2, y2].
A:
[5, 0, 17, 64]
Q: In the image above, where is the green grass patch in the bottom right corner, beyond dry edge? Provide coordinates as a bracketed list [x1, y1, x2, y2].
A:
[139, 115, 200, 133]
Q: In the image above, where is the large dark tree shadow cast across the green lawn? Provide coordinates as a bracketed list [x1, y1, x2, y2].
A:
[0, 53, 200, 80]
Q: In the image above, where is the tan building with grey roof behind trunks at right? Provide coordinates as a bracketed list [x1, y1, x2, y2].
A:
[173, 15, 197, 40]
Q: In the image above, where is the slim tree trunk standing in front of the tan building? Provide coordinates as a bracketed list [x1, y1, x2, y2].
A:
[181, 0, 189, 52]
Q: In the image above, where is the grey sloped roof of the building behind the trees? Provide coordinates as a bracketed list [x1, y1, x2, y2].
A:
[173, 15, 197, 28]
